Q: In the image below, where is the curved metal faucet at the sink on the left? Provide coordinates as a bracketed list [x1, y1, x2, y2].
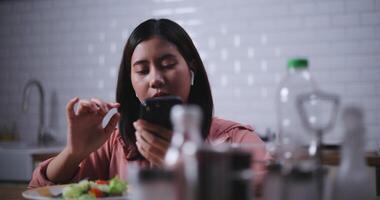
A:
[22, 79, 54, 145]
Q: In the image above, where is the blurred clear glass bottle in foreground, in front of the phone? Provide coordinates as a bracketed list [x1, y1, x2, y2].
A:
[165, 105, 202, 200]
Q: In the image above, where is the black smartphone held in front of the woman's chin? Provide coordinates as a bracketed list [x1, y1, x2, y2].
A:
[140, 96, 182, 130]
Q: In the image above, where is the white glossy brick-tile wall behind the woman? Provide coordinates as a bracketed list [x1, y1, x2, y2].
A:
[0, 0, 380, 150]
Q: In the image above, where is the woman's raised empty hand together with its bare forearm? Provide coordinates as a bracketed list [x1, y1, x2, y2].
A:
[46, 98, 120, 183]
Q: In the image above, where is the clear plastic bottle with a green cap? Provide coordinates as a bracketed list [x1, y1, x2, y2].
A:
[276, 58, 317, 165]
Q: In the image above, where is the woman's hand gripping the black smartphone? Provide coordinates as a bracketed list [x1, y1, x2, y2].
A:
[133, 119, 173, 167]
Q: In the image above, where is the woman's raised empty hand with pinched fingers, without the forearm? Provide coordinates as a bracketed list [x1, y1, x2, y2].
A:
[66, 98, 120, 157]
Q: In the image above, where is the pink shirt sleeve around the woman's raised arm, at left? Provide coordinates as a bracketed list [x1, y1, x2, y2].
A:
[28, 132, 116, 188]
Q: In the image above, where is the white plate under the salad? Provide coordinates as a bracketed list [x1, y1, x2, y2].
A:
[22, 185, 128, 200]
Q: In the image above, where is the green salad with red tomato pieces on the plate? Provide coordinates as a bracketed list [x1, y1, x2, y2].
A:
[62, 177, 128, 200]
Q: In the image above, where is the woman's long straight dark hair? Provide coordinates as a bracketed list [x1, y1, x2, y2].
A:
[116, 19, 214, 159]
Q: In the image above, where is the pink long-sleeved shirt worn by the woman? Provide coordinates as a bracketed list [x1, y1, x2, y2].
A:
[28, 117, 269, 188]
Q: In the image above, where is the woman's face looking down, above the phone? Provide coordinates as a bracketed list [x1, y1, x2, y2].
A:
[131, 37, 190, 102]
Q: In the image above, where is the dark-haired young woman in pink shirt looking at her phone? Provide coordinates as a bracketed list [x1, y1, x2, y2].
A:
[29, 19, 267, 188]
